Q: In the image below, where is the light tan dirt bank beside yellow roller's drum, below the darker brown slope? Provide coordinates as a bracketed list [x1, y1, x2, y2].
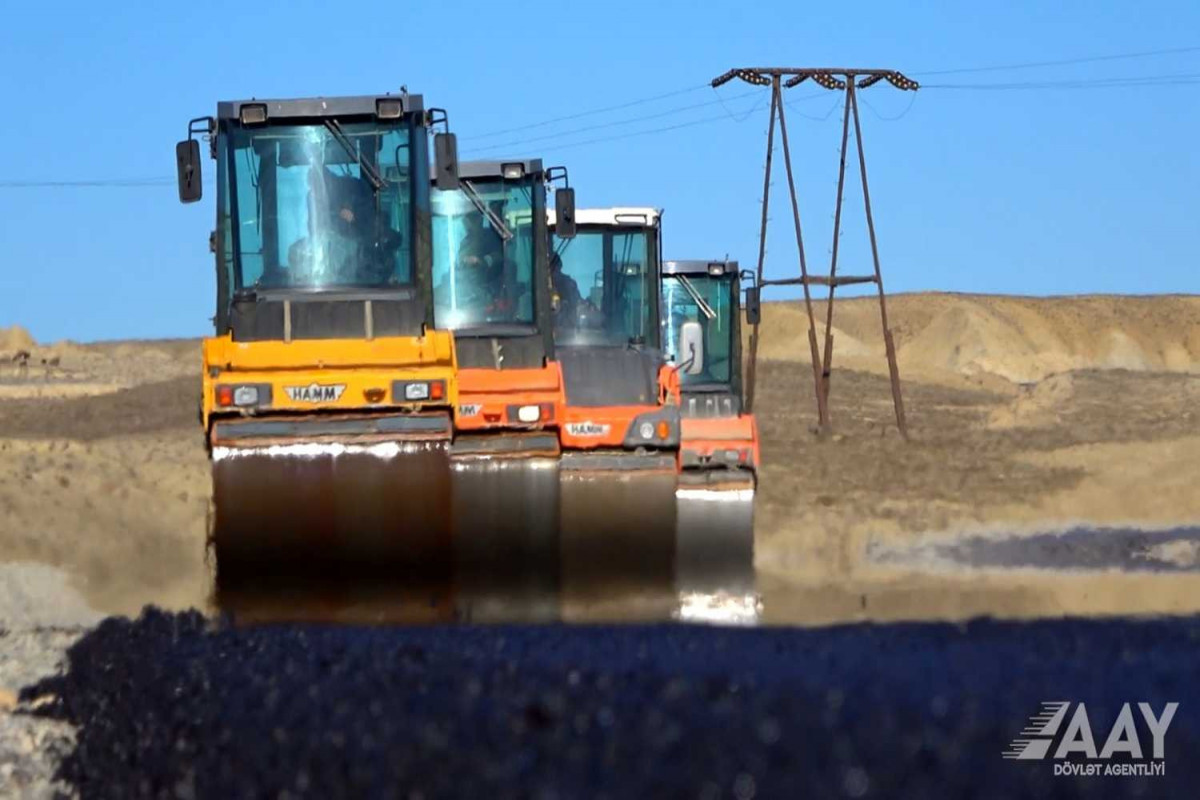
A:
[0, 431, 210, 626]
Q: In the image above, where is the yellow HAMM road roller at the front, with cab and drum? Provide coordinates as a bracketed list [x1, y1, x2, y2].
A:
[176, 94, 457, 587]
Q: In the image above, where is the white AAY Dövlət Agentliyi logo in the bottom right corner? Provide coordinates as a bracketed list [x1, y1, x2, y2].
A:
[1004, 700, 1180, 775]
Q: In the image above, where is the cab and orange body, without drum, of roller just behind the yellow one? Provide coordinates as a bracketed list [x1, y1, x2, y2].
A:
[431, 160, 574, 443]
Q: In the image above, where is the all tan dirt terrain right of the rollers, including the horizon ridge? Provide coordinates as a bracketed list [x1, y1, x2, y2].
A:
[739, 294, 1200, 621]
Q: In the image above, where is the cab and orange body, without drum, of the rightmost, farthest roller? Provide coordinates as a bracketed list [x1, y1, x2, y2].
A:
[662, 260, 758, 481]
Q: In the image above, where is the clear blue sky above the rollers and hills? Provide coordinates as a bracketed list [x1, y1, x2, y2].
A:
[0, 0, 1200, 341]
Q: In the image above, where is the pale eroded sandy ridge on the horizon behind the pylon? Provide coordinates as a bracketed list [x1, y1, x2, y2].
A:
[760, 294, 1200, 384]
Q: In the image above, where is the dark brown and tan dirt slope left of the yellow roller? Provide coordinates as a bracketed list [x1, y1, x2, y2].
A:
[0, 378, 209, 613]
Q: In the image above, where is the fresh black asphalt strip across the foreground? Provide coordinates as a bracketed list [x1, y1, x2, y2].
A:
[24, 609, 1200, 800]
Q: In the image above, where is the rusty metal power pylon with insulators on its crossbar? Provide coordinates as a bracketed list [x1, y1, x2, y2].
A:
[713, 67, 919, 439]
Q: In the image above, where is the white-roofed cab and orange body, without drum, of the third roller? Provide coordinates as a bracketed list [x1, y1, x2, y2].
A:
[551, 207, 679, 455]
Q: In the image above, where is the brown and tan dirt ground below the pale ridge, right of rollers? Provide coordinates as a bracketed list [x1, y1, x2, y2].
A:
[756, 361, 1200, 622]
